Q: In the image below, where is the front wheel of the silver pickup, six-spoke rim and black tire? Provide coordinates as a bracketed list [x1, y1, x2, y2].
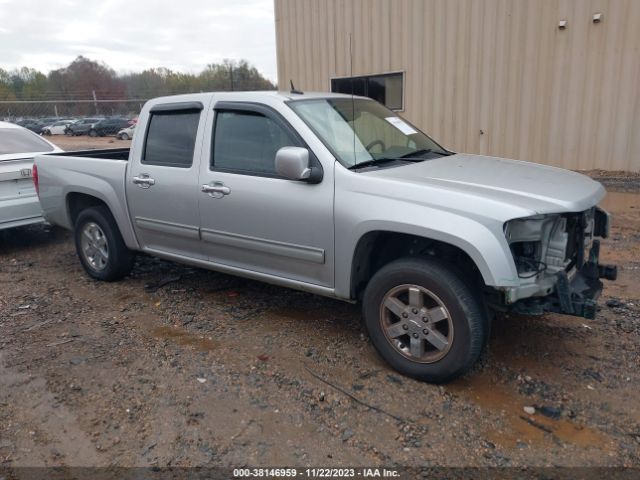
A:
[363, 258, 488, 383]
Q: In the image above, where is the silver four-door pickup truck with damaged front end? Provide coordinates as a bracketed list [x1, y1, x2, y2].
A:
[35, 91, 616, 382]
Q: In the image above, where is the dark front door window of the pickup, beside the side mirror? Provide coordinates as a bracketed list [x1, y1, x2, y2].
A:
[211, 111, 297, 175]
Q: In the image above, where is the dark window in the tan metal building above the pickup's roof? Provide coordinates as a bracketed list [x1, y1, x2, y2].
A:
[331, 73, 404, 110]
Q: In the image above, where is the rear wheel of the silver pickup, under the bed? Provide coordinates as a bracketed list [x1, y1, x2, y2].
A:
[74, 206, 135, 282]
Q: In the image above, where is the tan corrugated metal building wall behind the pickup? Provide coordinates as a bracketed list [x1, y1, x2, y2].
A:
[275, 0, 640, 171]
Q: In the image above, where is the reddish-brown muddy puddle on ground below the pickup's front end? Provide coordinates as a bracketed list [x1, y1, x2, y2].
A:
[447, 375, 611, 451]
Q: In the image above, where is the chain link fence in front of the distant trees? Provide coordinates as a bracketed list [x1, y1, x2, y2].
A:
[0, 98, 147, 122]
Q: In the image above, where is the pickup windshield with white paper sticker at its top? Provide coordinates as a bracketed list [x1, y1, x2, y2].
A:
[289, 98, 449, 169]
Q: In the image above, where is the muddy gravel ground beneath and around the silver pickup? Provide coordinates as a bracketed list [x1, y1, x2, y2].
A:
[0, 142, 640, 467]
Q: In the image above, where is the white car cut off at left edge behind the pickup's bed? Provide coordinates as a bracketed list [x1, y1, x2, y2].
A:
[0, 122, 62, 230]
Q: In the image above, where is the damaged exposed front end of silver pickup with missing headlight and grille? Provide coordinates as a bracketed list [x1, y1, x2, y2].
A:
[495, 207, 617, 318]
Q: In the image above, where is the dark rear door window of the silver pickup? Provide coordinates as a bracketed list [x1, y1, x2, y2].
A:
[142, 110, 200, 168]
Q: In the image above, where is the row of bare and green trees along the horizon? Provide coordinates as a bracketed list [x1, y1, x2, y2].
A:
[0, 56, 276, 116]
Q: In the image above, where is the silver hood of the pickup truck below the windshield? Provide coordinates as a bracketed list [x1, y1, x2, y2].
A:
[370, 154, 606, 215]
